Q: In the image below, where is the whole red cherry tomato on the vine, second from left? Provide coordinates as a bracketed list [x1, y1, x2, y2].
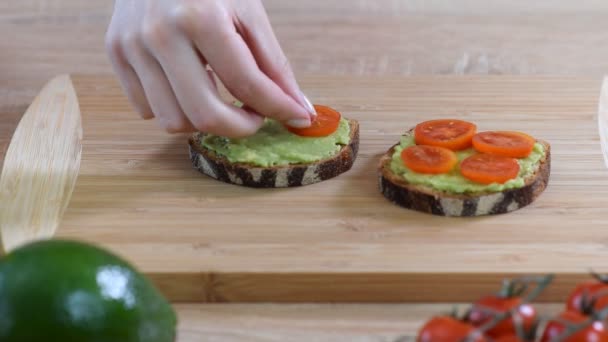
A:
[468, 296, 538, 338]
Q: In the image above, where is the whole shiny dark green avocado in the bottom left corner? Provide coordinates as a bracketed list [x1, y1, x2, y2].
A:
[0, 240, 177, 342]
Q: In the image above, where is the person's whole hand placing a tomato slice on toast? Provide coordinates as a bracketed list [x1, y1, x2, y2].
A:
[106, 0, 314, 137]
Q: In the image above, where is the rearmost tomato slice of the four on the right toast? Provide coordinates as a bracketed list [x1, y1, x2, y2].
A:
[414, 119, 477, 151]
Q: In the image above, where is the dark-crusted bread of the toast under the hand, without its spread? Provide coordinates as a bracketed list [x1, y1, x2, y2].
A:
[189, 120, 359, 188]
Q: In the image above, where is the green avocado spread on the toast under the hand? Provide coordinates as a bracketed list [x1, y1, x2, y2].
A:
[201, 118, 350, 167]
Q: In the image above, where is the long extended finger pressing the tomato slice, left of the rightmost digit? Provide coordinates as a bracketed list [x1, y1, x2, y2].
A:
[172, 5, 310, 127]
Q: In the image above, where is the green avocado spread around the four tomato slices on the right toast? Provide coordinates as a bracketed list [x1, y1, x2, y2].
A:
[390, 136, 545, 193]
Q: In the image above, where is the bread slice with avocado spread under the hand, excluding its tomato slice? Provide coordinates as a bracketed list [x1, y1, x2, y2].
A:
[189, 106, 359, 188]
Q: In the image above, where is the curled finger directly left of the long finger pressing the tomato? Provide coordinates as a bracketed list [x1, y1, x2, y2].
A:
[147, 30, 263, 138]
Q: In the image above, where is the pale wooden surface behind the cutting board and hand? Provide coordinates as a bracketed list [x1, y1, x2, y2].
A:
[0, 0, 608, 171]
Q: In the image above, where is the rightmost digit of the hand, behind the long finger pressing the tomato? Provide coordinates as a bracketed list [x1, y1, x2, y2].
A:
[237, 0, 315, 115]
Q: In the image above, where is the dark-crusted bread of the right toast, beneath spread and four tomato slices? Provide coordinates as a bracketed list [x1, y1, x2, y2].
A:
[378, 131, 551, 217]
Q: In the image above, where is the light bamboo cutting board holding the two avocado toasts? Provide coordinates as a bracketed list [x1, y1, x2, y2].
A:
[48, 75, 608, 302]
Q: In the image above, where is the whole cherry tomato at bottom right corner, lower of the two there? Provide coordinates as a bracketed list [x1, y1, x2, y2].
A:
[541, 311, 608, 342]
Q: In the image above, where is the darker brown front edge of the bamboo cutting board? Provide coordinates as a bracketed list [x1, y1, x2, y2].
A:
[147, 273, 590, 303]
